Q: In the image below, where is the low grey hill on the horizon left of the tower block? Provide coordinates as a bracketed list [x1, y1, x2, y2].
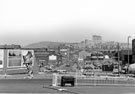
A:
[24, 41, 72, 48]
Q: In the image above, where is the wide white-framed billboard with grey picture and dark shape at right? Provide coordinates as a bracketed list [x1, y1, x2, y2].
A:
[7, 50, 34, 68]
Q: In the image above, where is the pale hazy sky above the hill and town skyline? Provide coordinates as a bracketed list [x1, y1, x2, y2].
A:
[0, 0, 135, 45]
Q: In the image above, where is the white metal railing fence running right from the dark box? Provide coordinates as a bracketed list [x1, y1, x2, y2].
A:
[53, 73, 135, 86]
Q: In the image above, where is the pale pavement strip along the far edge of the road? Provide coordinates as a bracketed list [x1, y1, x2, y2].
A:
[0, 72, 135, 81]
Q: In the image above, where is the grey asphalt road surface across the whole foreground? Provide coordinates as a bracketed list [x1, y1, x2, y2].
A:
[0, 78, 135, 94]
